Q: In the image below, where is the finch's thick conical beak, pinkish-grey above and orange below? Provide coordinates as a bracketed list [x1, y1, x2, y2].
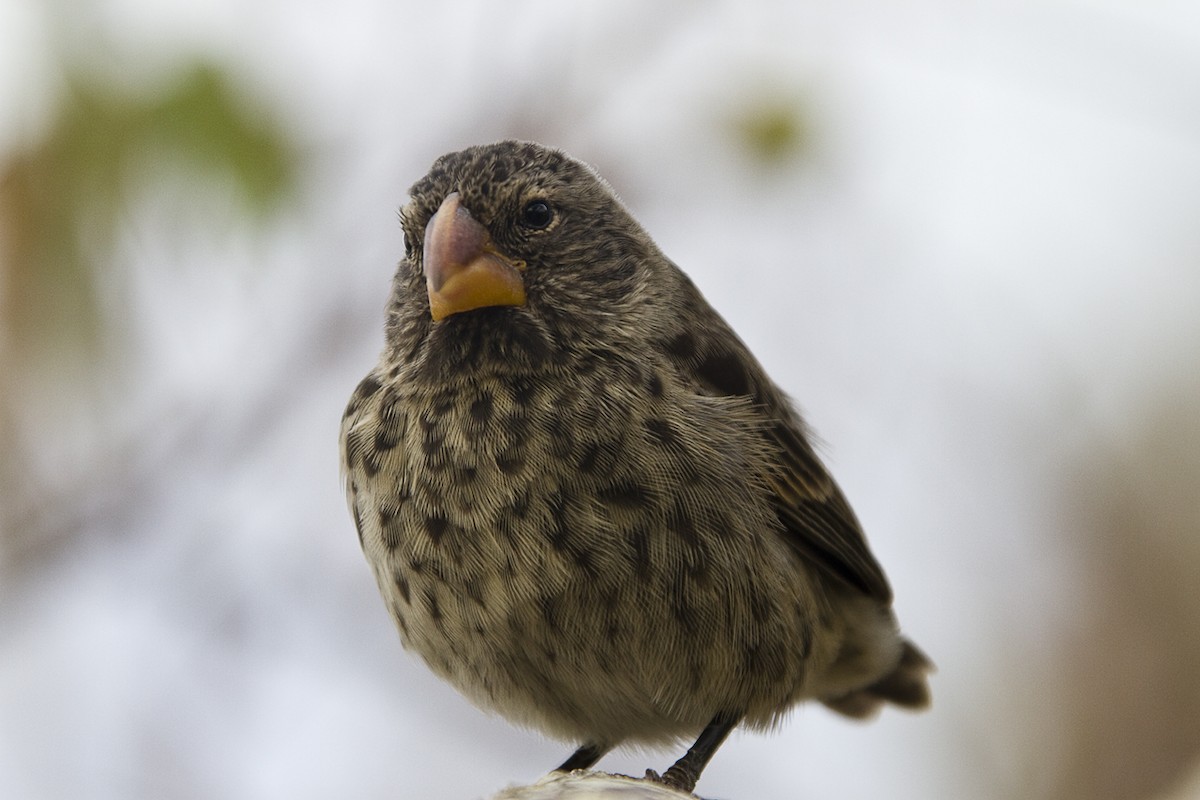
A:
[425, 192, 526, 321]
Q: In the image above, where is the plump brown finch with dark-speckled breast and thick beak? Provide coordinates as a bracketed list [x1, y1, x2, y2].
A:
[341, 140, 932, 792]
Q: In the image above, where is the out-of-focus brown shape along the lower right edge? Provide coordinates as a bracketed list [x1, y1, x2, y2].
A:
[1055, 375, 1200, 800]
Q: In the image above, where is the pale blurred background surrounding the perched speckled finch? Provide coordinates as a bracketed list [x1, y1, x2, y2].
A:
[0, 0, 1200, 800]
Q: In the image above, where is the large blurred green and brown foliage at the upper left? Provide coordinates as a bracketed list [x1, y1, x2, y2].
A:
[0, 64, 296, 355]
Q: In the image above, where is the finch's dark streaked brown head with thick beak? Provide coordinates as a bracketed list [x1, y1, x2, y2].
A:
[390, 142, 668, 376]
